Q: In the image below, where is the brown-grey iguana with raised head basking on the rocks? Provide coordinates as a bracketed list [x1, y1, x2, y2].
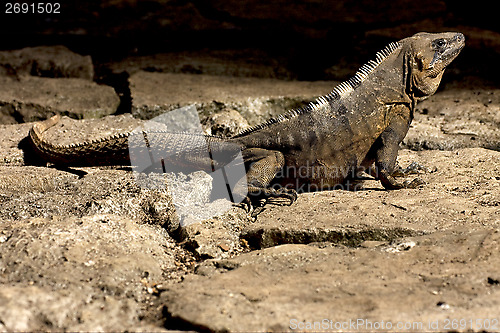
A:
[30, 32, 465, 208]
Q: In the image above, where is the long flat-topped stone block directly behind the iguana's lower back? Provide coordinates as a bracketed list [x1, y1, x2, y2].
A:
[129, 72, 337, 120]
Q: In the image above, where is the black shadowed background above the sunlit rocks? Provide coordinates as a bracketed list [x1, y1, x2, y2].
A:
[0, 0, 500, 84]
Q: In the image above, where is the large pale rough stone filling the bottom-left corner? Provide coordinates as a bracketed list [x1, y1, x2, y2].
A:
[0, 215, 191, 331]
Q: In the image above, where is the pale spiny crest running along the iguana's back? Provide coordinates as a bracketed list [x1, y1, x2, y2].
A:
[234, 42, 401, 138]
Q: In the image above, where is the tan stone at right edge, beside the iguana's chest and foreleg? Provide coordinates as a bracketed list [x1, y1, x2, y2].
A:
[403, 88, 500, 150]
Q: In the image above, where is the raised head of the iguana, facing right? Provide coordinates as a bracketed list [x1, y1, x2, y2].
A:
[409, 32, 465, 99]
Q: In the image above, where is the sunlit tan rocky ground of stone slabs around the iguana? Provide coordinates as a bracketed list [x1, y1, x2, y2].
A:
[0, 35, 500, 332]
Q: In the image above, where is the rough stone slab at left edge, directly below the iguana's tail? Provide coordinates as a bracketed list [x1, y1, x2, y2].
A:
[0, 166, 178, 230]
